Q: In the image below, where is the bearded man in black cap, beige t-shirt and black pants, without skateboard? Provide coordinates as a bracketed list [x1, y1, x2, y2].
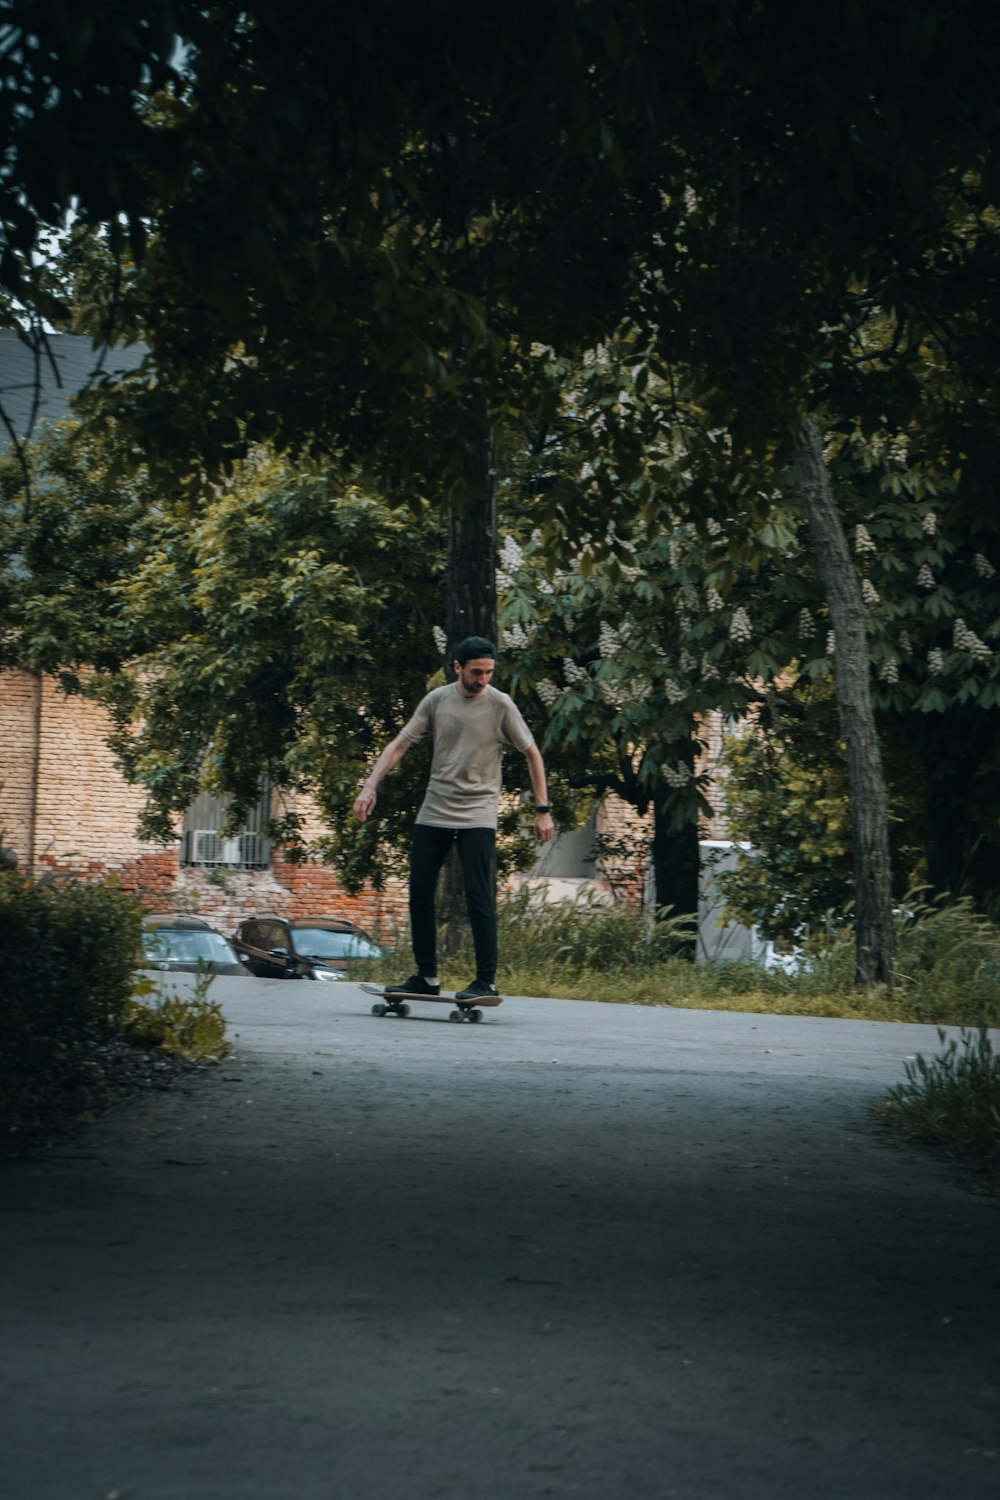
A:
[354, 636, 555, 1001]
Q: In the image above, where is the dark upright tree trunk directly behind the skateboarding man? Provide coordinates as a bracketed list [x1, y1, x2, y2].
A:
[438, 383, 496, 957]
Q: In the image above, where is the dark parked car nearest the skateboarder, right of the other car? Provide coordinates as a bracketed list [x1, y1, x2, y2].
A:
[232, 915, 382, 980]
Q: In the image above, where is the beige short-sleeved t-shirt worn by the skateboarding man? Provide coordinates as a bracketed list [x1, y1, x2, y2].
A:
[400, 683, 535, 828]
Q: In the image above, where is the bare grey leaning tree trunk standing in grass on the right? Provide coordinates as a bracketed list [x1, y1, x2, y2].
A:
[795, 417, 895, 986]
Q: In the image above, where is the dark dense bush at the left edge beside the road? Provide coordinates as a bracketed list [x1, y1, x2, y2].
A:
[0, 875, 142, 1089]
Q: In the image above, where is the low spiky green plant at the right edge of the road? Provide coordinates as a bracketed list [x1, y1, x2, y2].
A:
[877, 1025, 1000, 1190]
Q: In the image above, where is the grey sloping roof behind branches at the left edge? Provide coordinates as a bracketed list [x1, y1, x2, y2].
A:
[0, 329, 148, 447]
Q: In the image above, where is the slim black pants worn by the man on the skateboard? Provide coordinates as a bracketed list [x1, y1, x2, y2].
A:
[409, 824, 496, 984]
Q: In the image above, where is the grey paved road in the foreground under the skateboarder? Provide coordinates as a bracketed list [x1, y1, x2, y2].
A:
[0, 980, 1000, 1500]
